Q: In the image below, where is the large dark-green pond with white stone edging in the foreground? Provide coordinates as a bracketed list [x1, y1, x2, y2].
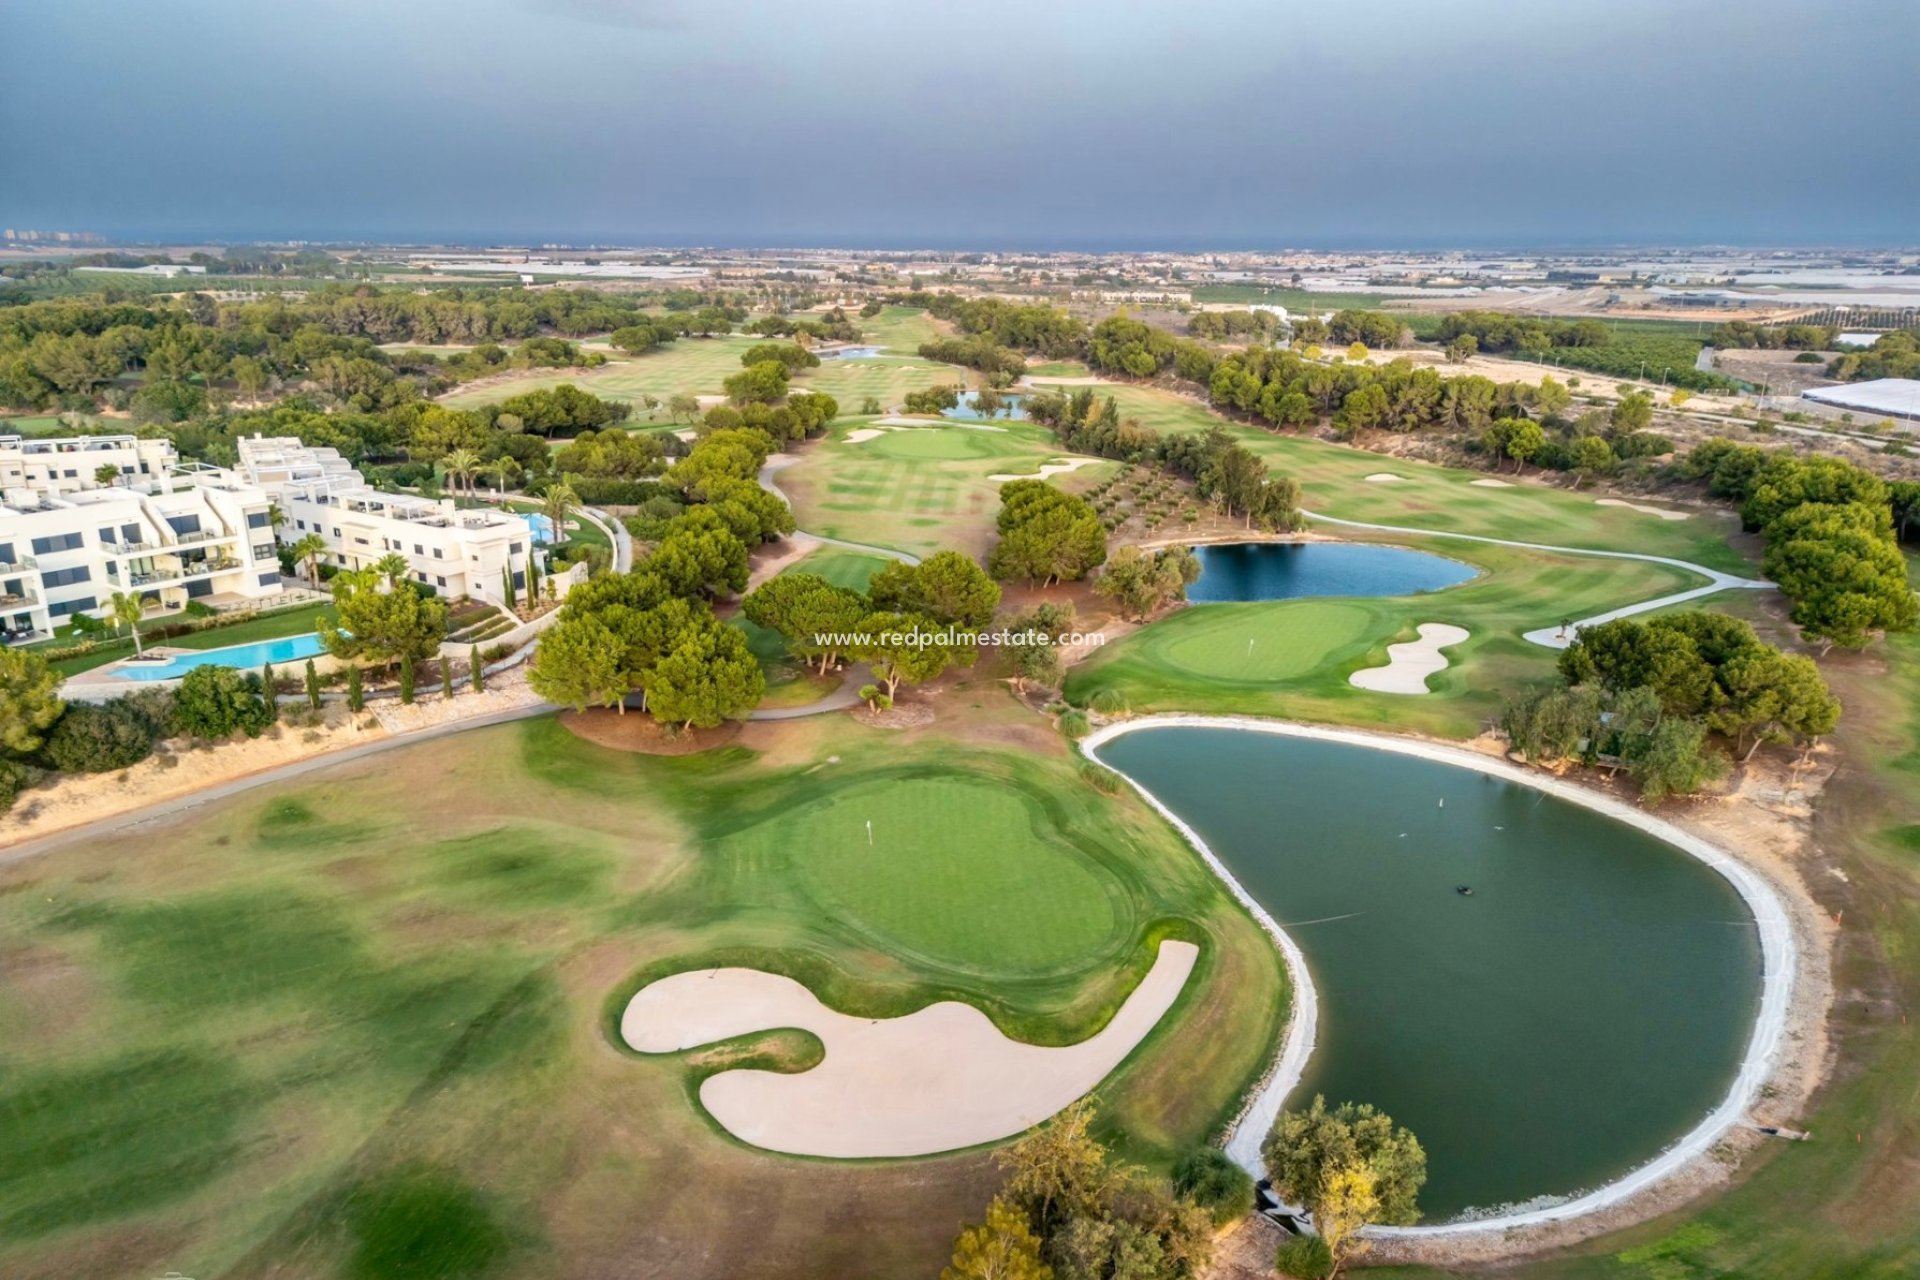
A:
[1098, 725, 1763, 1222]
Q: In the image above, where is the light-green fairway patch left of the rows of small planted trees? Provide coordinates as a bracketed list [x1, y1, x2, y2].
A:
[780, 420, 1119, 555]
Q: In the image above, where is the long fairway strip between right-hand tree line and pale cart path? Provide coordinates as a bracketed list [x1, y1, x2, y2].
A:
[1098, 386, 1757, 574]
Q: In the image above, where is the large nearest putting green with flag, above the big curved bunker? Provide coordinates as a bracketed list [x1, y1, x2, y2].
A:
[724, 777, 1133, 975]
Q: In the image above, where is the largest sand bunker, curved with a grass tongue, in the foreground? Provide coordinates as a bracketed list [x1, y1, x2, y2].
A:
[620, 940, 1200, 1159]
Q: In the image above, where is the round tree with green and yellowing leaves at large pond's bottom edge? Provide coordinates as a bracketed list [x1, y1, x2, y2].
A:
[1260, 1096, 1427, 1226]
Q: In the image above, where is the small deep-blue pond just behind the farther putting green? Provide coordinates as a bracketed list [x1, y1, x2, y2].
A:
[1187, 543, 1475, 603]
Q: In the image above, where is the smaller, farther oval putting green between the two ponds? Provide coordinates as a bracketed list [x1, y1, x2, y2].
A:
[1148, 601, 1379, 683]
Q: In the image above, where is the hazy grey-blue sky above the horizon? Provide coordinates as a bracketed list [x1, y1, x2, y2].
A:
[0, 0, 1920, 249]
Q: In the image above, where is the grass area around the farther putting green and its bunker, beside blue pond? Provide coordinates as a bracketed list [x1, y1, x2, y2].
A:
[1066, 535, 1701, 737]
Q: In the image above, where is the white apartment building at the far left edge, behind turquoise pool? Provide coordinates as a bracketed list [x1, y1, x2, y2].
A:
[0, 436, 284, 641]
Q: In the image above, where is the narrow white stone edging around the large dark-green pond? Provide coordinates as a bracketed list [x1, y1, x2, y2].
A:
[1079, 714, 1799, 1240]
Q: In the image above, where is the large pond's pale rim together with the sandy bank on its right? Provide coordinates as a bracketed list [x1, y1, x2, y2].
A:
[1081, 716, 1837, 1265]
